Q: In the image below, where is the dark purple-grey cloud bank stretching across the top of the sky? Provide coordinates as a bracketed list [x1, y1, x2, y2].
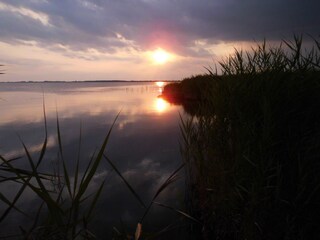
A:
[0, 0, 320, 55]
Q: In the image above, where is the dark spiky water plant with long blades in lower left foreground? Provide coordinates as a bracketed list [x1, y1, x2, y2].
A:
[0, 109, 118, 239]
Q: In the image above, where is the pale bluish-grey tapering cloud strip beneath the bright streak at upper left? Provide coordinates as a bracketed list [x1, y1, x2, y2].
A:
[0, 4, 130, 53]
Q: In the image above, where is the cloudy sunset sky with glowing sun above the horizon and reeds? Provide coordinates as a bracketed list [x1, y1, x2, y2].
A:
[0, 0, 320, 81]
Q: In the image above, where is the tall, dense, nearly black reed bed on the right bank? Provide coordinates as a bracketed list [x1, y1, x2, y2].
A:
[175, 37, 320, 239]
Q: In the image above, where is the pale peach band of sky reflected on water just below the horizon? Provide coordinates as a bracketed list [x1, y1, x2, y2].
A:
[0, 83, 177, 125]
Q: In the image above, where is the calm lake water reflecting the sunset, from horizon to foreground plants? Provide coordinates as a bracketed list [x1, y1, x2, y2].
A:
[0, 82, 184, 239]
